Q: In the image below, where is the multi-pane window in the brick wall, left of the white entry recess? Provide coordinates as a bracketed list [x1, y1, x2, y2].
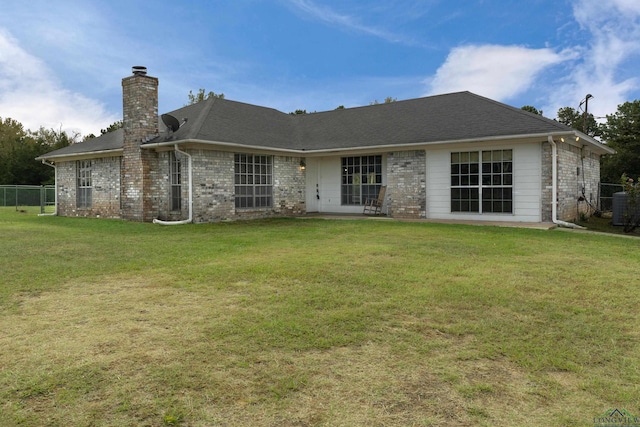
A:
[234, 154, 273, 209]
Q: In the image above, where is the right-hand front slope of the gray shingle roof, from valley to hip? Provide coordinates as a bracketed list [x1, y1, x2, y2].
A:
[292, 92, 572, 150]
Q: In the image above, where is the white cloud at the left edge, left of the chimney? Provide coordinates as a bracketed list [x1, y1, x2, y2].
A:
[0, 29, 119, 135]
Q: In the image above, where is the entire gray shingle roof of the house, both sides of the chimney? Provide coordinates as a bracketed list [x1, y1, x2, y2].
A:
[41, 92, 608, 158]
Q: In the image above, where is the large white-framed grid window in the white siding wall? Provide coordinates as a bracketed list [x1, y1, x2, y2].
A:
[451, 150, 513, 213]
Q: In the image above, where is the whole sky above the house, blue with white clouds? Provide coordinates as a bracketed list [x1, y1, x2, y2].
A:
[0, 0, 640, 135]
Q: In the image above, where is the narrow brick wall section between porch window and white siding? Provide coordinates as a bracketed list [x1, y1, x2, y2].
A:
[387, 150, 427, 218]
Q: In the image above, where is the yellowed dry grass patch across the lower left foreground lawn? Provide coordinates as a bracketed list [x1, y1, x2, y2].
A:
[0, 275, 604, 426]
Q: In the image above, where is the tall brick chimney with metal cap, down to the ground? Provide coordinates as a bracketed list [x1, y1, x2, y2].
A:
[120, 66, 158, 221]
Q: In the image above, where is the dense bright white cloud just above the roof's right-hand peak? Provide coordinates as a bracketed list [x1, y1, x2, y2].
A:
[427, 45, 574, 101]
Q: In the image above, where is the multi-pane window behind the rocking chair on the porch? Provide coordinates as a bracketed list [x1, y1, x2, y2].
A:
[341, 156, 382, 205]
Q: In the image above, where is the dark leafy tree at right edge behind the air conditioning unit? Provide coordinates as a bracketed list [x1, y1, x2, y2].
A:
[601, 100, 640, 182]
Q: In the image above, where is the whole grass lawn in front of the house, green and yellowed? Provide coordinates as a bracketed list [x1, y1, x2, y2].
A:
[0, 209, 640, 426]
